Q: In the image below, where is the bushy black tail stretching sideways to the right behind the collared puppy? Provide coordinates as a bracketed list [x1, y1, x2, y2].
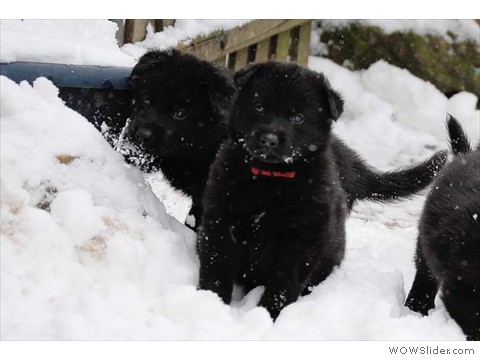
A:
[357, 151, 447, 205]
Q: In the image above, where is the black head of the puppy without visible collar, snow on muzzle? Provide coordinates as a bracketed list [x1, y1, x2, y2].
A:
[124, 50, 235, 158]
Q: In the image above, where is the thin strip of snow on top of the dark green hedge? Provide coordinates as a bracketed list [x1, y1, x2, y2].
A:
[321, 19, 480, 43]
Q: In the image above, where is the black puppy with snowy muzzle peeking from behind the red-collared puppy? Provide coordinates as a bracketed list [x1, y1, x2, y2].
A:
[119, 50, 236, 227]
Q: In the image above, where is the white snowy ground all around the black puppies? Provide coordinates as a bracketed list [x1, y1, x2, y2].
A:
[0, 19, 480, 340]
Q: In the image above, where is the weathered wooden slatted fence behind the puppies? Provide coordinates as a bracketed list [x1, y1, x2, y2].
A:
[117, 20, 311, 70]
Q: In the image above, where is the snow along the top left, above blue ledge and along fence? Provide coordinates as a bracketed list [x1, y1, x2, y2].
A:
[0, 20, 248, 67]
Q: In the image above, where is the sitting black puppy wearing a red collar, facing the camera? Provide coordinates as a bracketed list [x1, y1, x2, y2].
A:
[198, 62, 348, 319]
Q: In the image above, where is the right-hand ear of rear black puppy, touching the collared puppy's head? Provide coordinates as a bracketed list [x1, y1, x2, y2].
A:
[208, 69, 237, 120]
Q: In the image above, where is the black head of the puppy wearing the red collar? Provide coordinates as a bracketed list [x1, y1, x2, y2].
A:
[230, 62, 343, 164]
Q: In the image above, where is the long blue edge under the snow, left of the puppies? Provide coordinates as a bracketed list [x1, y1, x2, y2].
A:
[0, 61, 132, 90]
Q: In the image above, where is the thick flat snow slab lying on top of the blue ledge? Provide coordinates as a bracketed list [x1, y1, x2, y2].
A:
[0, 20, 136, 67]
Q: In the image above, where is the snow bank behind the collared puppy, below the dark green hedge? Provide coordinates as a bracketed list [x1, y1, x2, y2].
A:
[309, 56, 480, 170]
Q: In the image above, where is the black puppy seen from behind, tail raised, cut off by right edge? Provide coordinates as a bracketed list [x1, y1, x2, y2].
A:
[405, 117, 480, 341]
